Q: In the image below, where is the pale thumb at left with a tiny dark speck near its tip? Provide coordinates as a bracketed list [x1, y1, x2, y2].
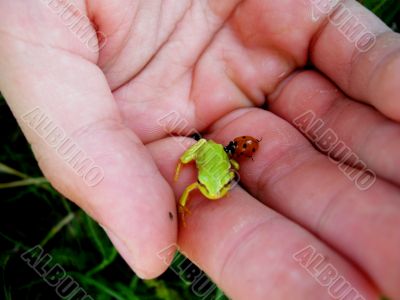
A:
[0, 1, 176, 278]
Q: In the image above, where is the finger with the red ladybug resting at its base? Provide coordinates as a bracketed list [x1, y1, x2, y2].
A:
[212, 109, 400, 298]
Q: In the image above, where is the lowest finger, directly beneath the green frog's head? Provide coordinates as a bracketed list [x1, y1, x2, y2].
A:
[148, 138, 378, 300]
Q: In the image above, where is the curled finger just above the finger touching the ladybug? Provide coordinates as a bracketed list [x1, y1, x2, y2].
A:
[270, 71, 400, 184]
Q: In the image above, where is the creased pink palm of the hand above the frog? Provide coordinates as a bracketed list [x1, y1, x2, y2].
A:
[101, 1, 311, 142]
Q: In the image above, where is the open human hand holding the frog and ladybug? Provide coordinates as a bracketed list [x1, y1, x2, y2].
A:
[0, 0, 400, 299]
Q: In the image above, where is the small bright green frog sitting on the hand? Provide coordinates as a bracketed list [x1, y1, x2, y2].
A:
[175, 139, 239, 225]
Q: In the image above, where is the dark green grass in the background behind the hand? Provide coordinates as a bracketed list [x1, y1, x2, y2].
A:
[0, 0, 400, 300]
